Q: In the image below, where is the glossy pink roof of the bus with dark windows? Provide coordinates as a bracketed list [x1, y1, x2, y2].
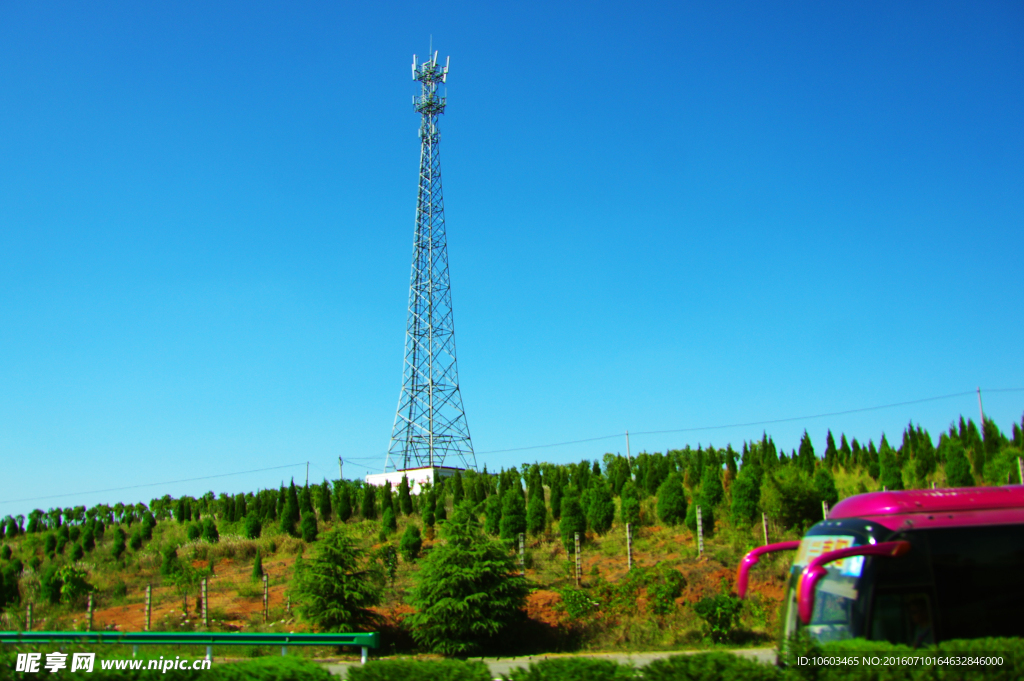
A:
[828, 484, 1024, 528]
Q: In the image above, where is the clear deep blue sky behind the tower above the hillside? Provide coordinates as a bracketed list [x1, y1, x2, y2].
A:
[0, 2, 1024, 514]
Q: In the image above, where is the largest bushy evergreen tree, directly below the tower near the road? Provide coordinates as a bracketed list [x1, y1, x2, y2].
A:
[407, 504, 528, 655]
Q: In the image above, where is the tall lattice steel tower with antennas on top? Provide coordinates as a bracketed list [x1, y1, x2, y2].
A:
[385, 52, 476, 470]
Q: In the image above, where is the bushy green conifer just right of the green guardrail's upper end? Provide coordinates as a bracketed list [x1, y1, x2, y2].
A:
[293, 528, 381, 632]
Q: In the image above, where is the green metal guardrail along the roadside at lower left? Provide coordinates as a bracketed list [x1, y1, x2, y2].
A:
[0, 632, 380, 664]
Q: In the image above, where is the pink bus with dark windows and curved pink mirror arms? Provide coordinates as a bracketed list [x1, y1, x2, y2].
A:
[736, 485, 1024, 647]
